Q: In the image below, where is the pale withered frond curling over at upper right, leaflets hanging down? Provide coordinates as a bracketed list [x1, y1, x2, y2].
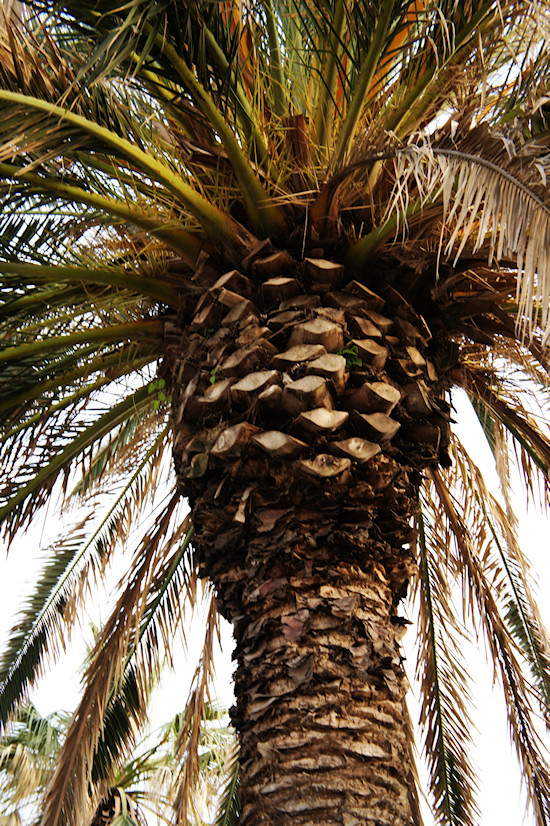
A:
[386, 140, 550, 344]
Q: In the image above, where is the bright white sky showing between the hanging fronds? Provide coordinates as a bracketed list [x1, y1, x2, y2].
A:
[0, 390, 550, 826]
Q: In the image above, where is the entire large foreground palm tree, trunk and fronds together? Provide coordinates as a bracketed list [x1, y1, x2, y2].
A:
[0, 0, 550, 826]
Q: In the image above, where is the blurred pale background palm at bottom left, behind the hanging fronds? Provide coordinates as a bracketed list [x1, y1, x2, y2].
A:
[0, 704, 238, 826]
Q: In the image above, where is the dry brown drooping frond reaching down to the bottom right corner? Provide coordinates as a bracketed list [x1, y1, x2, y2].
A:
[432, 440, 550, 826]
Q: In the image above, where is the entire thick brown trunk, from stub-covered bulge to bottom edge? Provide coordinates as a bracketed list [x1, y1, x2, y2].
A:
[165, 248, 454, 826]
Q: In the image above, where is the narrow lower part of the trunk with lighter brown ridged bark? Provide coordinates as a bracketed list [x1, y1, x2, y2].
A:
[234, 548, 414, 826]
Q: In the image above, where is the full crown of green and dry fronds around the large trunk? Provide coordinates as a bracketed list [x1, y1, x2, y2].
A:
[0, 0, 550, 824]
